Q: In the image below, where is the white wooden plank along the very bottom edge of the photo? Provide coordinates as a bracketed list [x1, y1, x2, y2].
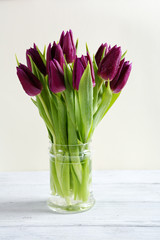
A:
[0, 226, 160, 240]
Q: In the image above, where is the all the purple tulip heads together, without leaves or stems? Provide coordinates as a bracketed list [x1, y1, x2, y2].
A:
[17, 30, 132, 96]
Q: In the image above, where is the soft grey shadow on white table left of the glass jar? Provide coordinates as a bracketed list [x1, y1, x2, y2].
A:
[0, 200, 54, 215]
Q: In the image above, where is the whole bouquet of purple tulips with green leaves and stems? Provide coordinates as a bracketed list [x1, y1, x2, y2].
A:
[17, 30, 131, 202]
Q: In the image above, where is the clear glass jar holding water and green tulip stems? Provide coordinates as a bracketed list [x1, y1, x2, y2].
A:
[48, 143, 95, 213]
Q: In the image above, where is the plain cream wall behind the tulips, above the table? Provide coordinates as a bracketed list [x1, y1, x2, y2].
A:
[0, 0, 160, 171]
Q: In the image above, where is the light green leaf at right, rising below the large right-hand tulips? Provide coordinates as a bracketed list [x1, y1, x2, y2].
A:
[93, 81, 112, 131]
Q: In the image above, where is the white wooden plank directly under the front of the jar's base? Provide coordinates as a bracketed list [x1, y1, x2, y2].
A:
[0, 201, 160, 227]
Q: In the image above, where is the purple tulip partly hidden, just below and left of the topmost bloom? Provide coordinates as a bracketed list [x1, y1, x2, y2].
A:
[47, 42, 65, 72]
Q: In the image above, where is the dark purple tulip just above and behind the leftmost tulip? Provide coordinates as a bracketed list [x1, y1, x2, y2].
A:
[26, 44, 46, 76]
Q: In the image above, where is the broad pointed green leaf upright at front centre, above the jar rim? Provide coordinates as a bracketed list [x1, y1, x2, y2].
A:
[78, 63, 93, 141]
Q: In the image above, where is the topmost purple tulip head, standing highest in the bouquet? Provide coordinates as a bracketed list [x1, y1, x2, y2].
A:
[59, 30, 76, 63]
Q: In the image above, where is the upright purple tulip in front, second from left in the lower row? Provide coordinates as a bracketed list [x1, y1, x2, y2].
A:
[48, 59, 66, 93]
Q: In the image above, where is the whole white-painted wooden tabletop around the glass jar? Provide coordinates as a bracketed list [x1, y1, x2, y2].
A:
[0, 171, 160, 240]
